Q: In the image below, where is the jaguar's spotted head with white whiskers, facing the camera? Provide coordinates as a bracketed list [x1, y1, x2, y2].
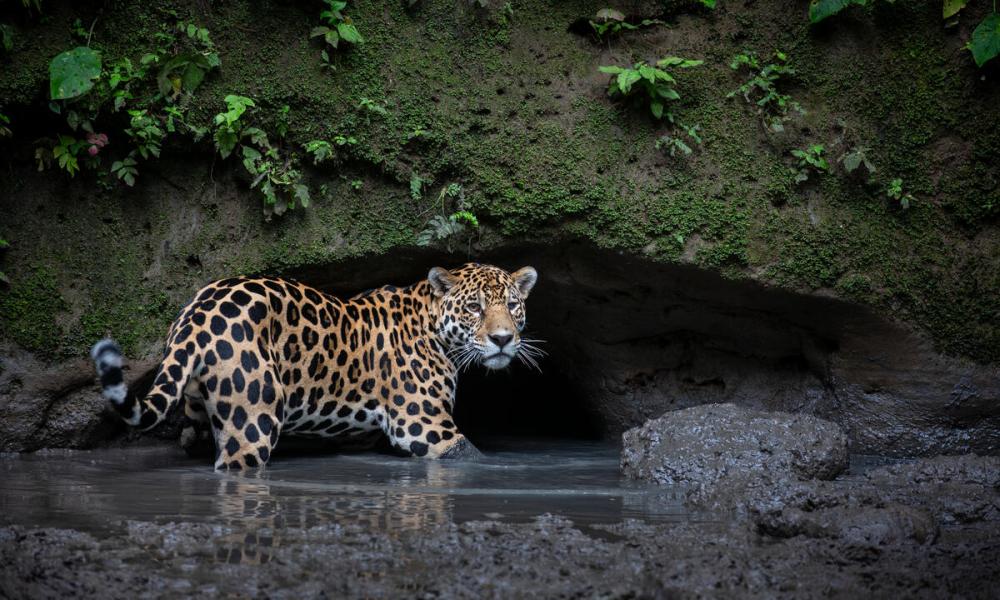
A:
[427, 263, 541, 369]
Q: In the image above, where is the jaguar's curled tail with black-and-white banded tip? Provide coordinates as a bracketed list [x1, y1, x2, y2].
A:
[90, 338, 194, 430]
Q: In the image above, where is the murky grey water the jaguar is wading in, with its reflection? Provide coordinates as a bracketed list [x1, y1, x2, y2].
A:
[0, 440, 690, 563]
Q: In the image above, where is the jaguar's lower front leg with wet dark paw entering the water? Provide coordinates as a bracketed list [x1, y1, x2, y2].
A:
[384, 395, 482, 460]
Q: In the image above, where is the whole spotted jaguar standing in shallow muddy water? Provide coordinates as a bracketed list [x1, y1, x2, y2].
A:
[91, 263, 538, 469]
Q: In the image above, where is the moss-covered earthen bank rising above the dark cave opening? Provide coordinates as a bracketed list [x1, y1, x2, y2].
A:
[0, 0, 1000, 362]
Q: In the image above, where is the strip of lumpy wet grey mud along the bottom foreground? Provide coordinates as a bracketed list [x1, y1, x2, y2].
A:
[0, 506, 1000, 598]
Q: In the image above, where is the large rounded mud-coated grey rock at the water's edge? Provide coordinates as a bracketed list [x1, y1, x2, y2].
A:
[621, 404, 848, 507]
